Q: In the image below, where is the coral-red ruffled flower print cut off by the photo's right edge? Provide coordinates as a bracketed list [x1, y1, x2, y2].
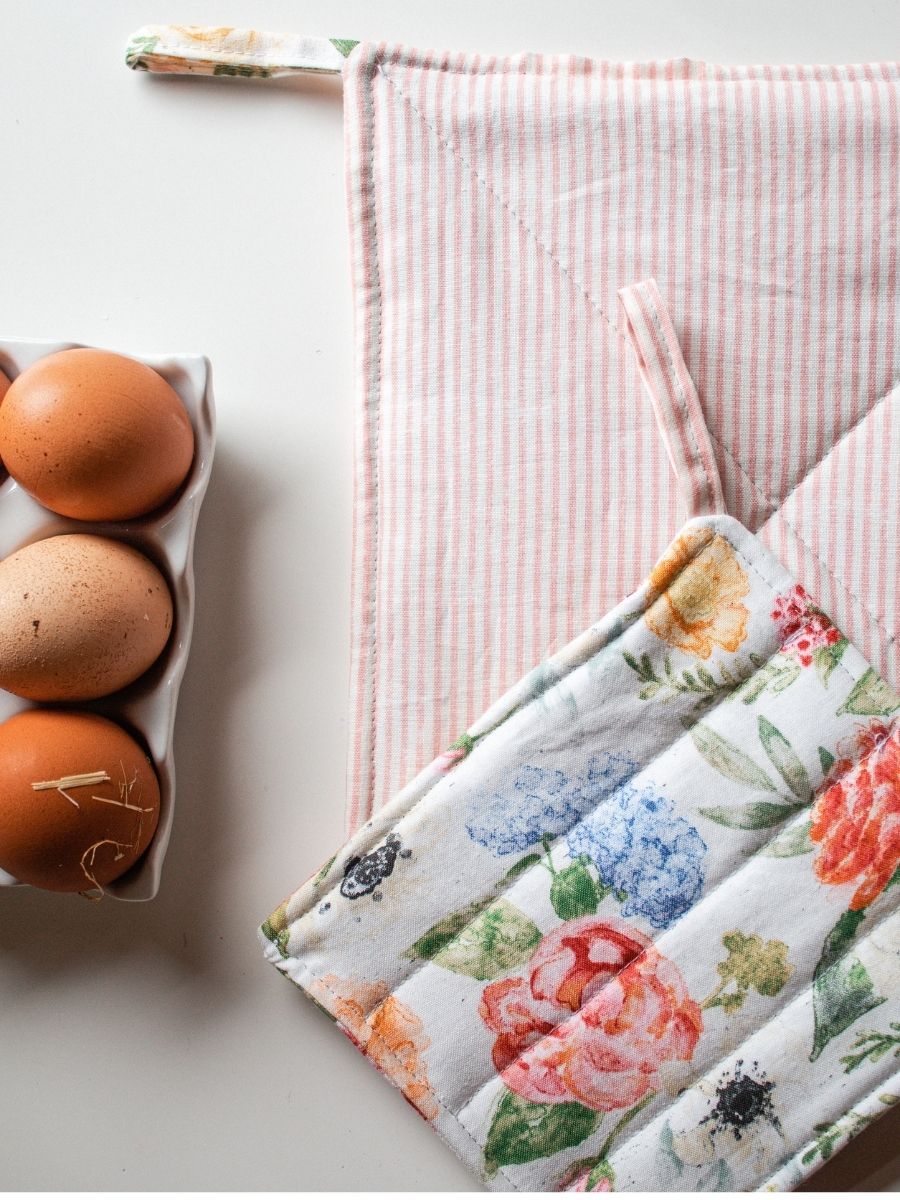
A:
[810, 721, 900, 911]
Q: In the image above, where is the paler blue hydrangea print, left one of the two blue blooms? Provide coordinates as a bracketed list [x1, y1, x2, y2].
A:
[466, 754, 637, 857]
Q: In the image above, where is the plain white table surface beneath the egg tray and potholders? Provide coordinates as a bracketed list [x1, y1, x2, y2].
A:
[0, 0, 900, 1192]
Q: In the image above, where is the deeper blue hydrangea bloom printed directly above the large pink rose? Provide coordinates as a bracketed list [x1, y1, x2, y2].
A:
[568, 786, 707, 929]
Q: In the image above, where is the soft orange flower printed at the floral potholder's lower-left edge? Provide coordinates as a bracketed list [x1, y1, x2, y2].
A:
[311, 974, 438, 1121]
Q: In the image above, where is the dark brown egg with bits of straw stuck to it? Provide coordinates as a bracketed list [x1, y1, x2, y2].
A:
[0, 709, 160, 892]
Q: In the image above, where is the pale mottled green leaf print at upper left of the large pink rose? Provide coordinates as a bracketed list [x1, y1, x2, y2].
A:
[406, 898, 541, 979]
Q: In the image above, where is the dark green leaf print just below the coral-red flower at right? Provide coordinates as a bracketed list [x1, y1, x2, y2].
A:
[809, 908, 887, 1062]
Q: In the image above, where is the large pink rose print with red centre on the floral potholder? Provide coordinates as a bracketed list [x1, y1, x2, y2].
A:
[480, 917, 702, 1112]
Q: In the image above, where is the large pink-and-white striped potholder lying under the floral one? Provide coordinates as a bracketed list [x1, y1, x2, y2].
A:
[344, 44, 900, 828]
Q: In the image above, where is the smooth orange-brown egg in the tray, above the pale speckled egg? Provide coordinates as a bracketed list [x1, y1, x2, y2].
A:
[0, 349, 193, 521]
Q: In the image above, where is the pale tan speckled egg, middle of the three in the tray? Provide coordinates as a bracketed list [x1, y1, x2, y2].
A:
[0, 533, 173, 701]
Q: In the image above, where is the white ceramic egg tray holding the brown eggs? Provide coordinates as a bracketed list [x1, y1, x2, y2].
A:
[0, 340, 215, 900]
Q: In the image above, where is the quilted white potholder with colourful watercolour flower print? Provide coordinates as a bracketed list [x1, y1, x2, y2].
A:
[262, 516, 900, 1192]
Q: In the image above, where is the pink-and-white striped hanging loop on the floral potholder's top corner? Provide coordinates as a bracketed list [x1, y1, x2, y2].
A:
[618, 280, 725, 517]
